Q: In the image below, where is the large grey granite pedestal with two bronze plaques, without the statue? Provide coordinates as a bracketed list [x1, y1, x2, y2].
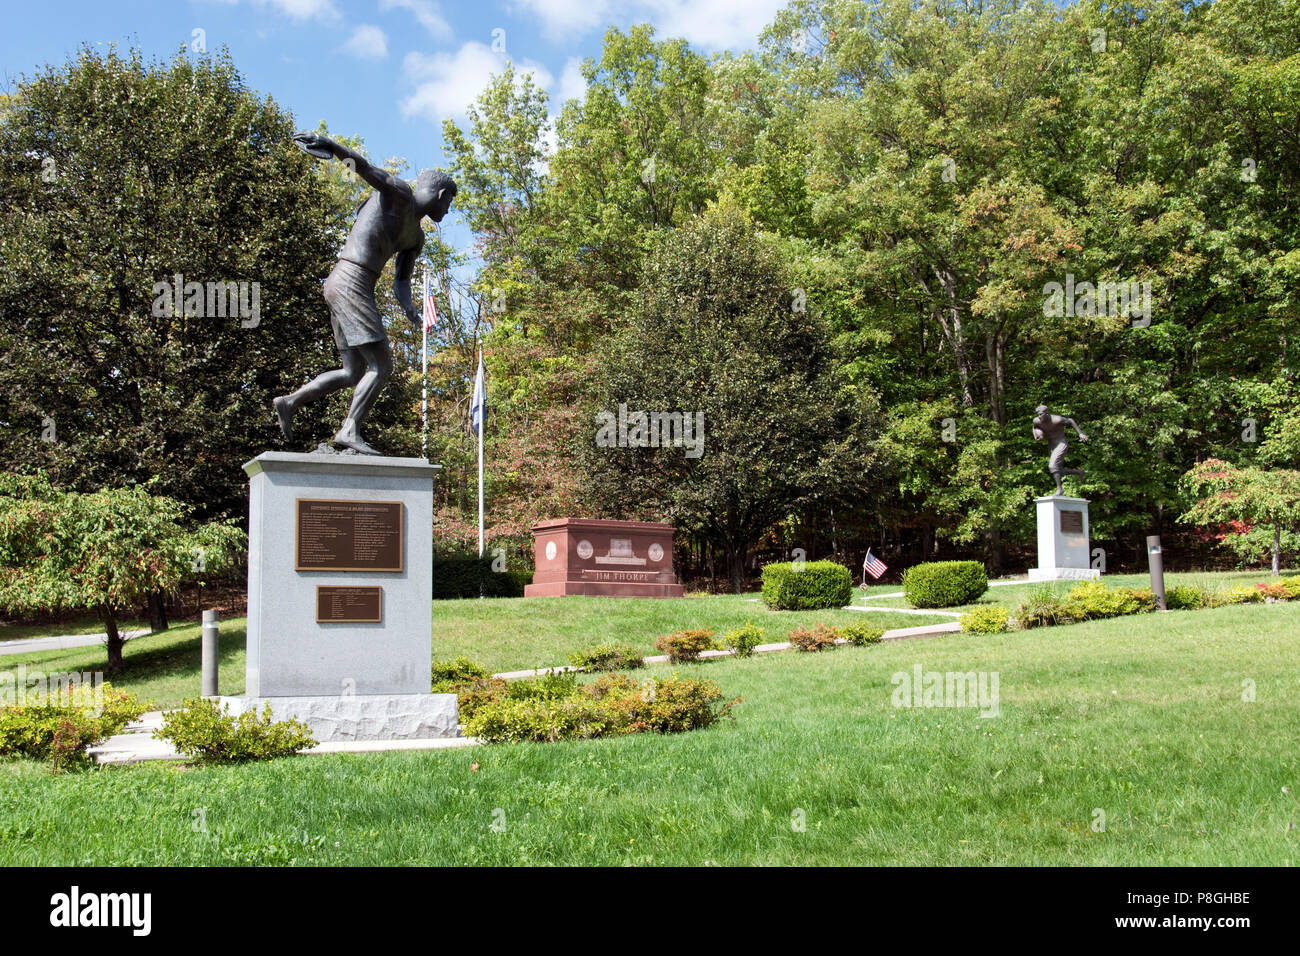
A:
[222, 451, 458, 743]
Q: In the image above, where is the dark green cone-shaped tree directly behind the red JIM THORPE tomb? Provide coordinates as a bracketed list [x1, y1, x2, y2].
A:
[580, 204, 867, 593]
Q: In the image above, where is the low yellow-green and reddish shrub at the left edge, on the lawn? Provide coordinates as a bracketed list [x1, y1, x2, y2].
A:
[0, 683, 150, 770]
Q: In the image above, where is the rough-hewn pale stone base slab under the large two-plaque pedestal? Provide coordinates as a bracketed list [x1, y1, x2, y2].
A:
[218, 693, 460, 744]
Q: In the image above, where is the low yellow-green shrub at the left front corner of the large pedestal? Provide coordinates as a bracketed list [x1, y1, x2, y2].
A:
[153, 697, 316, 763]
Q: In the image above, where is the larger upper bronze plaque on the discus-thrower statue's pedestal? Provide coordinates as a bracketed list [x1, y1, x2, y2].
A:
[294, 498, 403, 571]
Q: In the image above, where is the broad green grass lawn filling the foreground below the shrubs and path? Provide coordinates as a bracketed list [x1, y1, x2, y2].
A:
[0, 601, 1300, 866]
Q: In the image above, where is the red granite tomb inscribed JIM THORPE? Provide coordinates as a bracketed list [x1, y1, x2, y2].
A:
[524, 518, 684, 597]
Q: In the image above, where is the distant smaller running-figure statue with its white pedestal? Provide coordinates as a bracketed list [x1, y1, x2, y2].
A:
[1030, 405, 1101, 581]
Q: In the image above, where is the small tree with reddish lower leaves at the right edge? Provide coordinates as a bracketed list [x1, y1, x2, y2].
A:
[1182, 458, 1300, 575]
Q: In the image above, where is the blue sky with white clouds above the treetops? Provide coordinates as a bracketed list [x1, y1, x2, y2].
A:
[0, 0, 783, 261]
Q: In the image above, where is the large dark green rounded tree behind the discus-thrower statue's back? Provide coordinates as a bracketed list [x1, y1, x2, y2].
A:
[0, 48, 338, 515]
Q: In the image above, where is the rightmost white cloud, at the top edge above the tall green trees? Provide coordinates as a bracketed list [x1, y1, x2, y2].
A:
[511, 0, 785, 49]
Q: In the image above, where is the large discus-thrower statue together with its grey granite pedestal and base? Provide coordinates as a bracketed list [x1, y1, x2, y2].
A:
[221, 133, 459, 743]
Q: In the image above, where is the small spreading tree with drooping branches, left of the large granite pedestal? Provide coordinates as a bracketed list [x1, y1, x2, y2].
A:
[0, 473, 247, 671]
